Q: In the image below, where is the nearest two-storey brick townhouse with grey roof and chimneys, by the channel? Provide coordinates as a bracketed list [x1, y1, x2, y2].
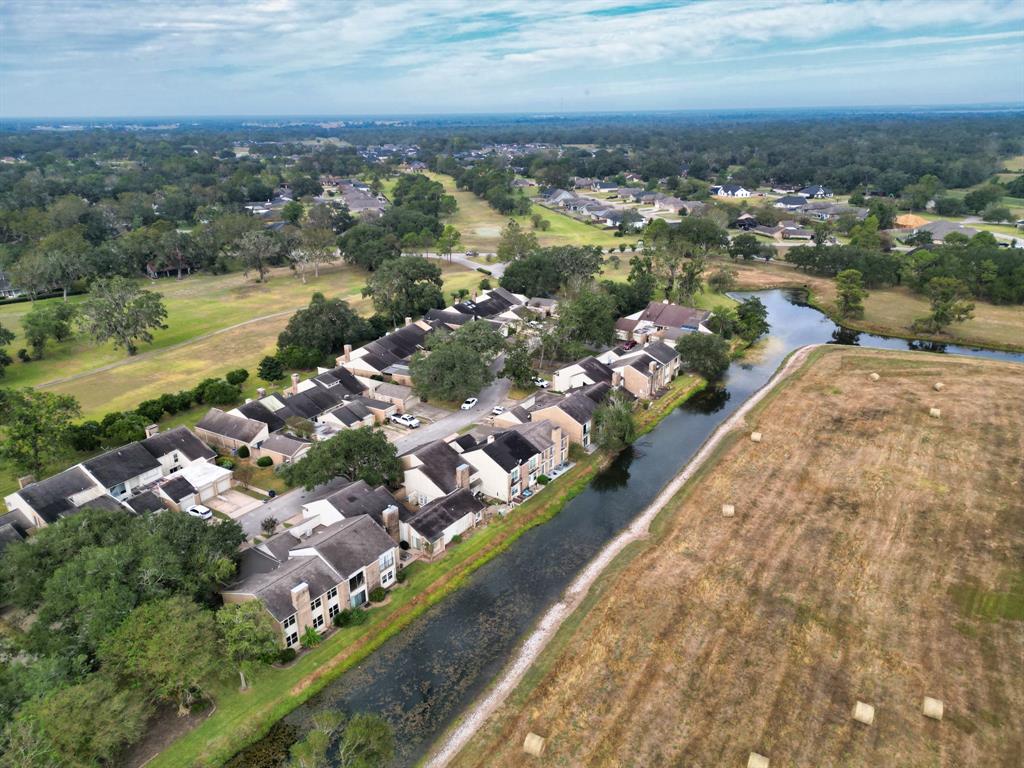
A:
[221, 515, 398, 648]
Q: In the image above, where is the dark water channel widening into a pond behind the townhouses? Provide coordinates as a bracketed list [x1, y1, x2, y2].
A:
[268, 291, 1024, 766]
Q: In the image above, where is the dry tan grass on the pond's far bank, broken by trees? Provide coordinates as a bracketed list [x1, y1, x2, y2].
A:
[710, 258, 1024, 349]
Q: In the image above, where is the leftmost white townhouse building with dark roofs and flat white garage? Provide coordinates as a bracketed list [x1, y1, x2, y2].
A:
[4, 425, 231, 527]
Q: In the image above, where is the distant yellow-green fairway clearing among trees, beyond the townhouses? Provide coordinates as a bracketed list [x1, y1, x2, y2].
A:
[413, 173, 622, 253]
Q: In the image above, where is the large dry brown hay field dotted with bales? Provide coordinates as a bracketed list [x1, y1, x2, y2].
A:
[453, 348, 1024, 768]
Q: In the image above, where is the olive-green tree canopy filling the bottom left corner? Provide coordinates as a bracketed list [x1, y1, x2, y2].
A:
[0, 674, 153, 768]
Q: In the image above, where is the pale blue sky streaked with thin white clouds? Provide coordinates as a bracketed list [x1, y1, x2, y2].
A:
[0, 0, 1024, 117]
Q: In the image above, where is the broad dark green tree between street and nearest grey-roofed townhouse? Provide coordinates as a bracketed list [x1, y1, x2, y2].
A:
[285, 427, 401, 490]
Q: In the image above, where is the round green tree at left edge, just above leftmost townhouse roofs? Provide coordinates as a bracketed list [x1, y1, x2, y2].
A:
[0, 387, 81, 474]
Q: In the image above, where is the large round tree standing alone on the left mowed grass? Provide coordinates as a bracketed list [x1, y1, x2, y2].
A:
[81, 276, 167, 355]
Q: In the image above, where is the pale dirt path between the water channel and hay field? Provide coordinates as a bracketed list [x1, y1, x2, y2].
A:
[425, 345, 817, 768]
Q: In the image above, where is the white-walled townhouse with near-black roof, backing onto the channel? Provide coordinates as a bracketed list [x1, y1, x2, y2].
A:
[462, 421, 568, 503]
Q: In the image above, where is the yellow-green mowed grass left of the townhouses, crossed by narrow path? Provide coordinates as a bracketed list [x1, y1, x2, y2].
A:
[0, 264, 480, 418]
